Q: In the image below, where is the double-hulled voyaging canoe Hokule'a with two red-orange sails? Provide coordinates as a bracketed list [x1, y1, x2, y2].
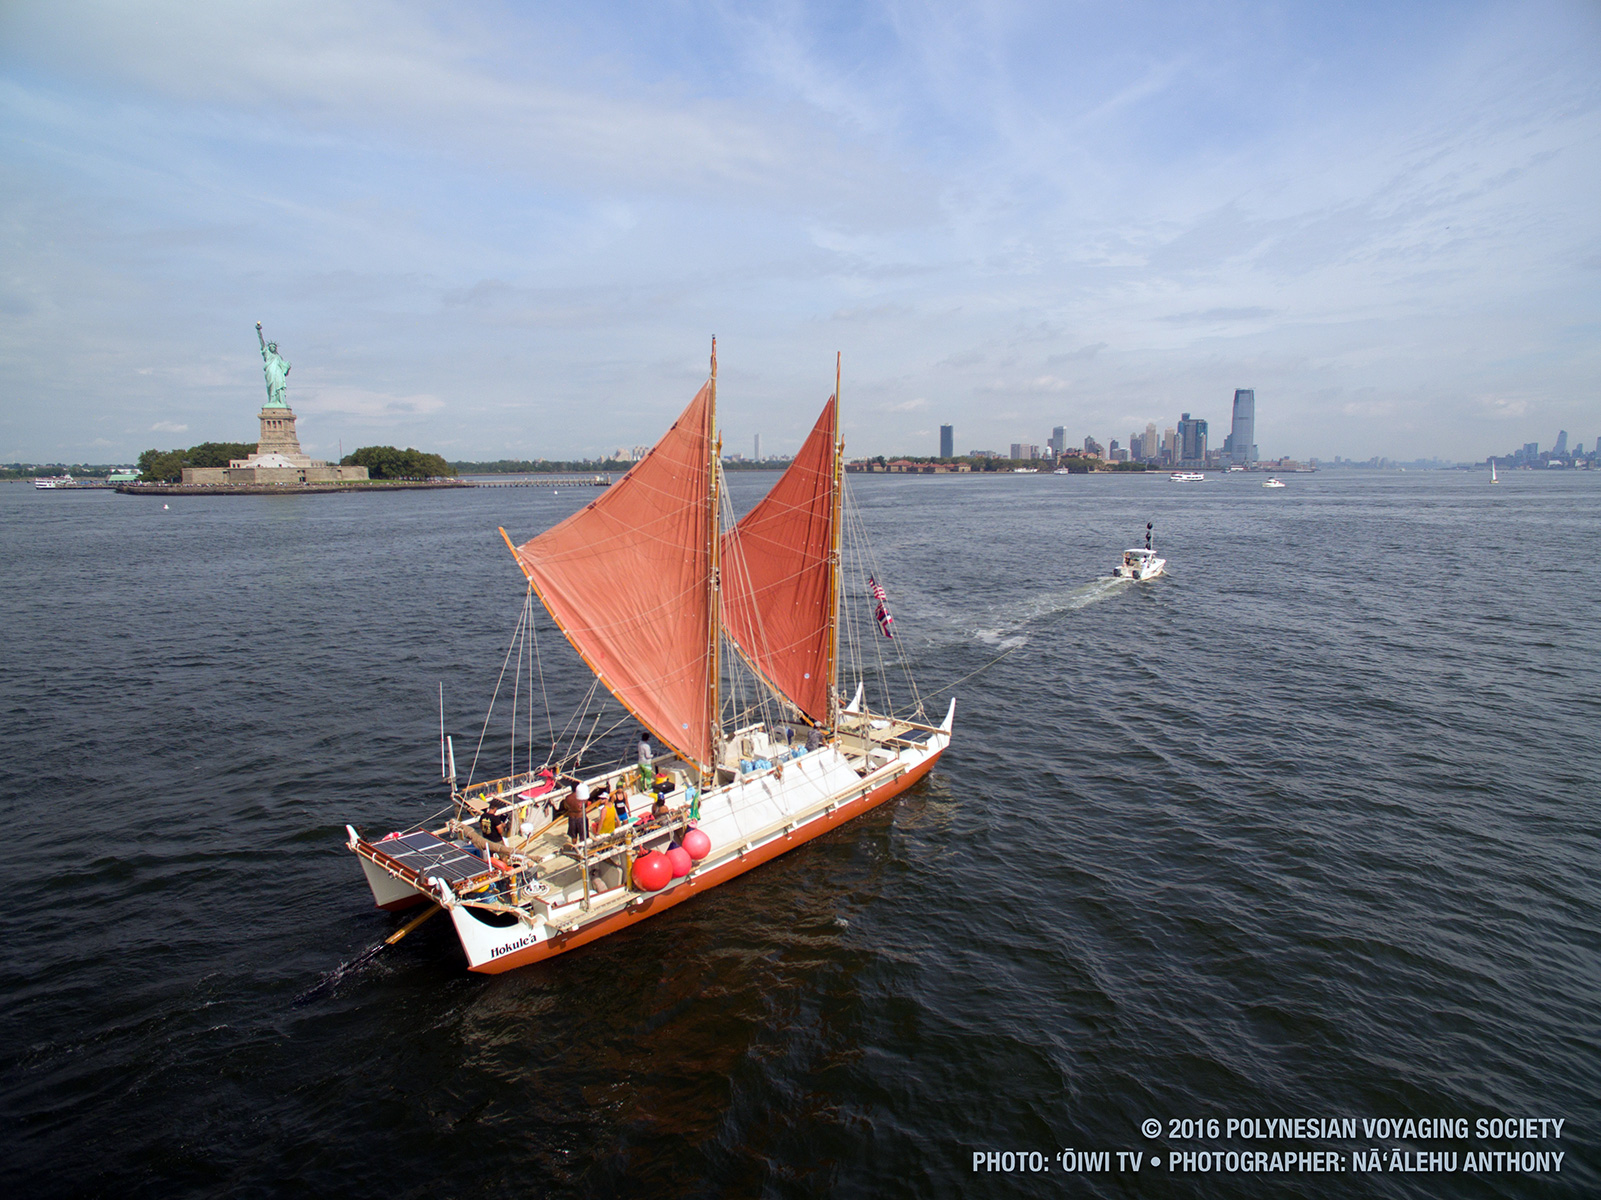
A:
[346, 339, 956, 973]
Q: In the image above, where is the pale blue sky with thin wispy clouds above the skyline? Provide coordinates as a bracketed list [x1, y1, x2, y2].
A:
[0, 0, 1601, 461]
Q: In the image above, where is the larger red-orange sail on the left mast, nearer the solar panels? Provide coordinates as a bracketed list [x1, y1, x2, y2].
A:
[508, 382, 716, 765]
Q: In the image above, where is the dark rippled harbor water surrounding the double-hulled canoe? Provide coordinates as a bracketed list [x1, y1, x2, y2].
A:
[0, 470, 1601, 1197]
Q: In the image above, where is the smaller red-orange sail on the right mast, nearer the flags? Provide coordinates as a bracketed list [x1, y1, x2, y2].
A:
[722, 397, 837, 723]
